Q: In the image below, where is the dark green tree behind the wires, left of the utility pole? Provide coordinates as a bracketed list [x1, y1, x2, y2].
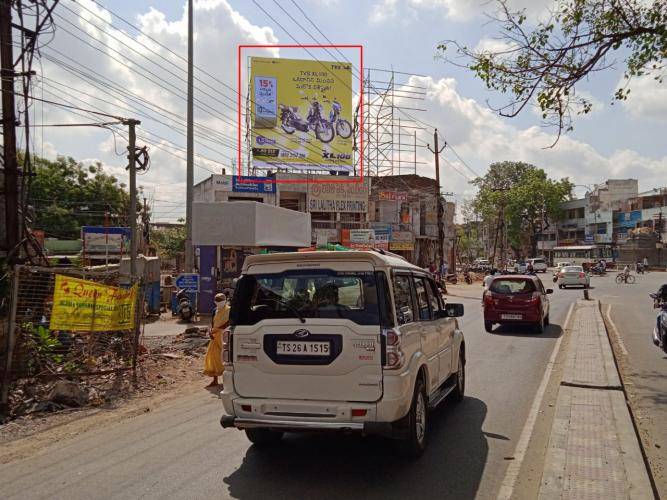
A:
[28, 156, 133, 239]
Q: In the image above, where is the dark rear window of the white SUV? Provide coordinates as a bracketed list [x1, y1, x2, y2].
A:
[232, 269, 380, 325]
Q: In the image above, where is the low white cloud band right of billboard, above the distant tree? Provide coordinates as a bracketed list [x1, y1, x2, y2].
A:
[392, 76, 667, 196]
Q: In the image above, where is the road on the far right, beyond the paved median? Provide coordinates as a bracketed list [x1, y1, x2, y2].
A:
[591, 272, 667, 498]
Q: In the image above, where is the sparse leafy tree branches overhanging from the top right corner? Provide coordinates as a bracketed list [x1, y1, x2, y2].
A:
[438, 0, 667, 144]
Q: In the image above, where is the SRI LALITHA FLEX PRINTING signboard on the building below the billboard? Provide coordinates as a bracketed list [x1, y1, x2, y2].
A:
[308, 178, 368, 213]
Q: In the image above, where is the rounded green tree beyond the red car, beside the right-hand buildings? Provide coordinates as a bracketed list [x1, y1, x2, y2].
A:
[472, 161, 574, 255]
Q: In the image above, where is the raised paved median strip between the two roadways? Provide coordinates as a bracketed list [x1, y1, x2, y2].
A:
[539, 299, 654, 500]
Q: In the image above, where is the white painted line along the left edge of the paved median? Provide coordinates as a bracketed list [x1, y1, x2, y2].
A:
[497, 302, 574, 500]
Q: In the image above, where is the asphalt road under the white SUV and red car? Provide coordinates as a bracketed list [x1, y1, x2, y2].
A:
[0, 282, 581, 500]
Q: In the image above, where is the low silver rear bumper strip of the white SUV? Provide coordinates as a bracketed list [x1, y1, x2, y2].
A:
[220, 415, 397, 437]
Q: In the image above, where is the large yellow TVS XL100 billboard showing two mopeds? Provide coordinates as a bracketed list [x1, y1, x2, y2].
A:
[250, 57, 354, 171]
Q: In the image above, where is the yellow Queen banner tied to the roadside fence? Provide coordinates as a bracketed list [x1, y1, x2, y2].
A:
[49, 274, 138, 332]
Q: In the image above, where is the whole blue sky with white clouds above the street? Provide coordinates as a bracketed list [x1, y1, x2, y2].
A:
[24, 0, 667, 221]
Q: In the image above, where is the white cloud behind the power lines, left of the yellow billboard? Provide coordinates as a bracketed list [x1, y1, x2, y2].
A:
[35, 0, 278, 221]
